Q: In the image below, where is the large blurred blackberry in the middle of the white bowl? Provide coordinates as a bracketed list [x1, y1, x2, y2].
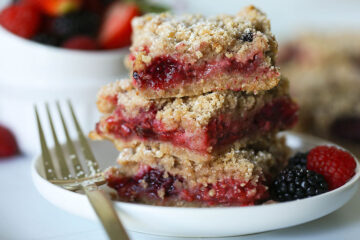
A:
[52, 10, 100, 39]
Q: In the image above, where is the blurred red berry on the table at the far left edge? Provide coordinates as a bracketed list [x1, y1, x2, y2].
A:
[0, 125, 19, 158]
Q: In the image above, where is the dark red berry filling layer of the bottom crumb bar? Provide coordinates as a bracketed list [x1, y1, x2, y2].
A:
[107, 165, 269, 206]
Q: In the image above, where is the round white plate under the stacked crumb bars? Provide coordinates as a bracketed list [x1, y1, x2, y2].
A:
[32, 132, 360, 237]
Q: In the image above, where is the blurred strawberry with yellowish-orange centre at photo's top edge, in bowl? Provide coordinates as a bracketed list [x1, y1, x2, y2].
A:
[30, 0, 83, 16]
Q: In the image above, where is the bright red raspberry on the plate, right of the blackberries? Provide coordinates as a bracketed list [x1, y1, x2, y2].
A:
[306, 146, 356, 190]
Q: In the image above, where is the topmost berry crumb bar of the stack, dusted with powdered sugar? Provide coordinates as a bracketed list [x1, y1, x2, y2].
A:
[129, 6, 280, 99]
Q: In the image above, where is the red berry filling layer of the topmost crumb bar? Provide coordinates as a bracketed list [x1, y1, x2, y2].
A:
[133, 53, 277, 90]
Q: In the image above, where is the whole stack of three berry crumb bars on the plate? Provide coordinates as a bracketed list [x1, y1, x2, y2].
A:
[90, 6, 298, 206]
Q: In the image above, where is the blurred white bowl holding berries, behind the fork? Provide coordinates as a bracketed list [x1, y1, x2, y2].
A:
[0, 0, 128, 153]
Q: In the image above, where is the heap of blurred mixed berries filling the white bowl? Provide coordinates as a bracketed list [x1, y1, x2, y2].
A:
[0, 0, 167, 50]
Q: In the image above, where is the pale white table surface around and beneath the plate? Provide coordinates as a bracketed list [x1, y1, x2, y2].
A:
[0, 156, 360, 240]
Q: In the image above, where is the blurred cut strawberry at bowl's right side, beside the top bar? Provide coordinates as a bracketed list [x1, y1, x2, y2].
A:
[99, 2, 140, 49]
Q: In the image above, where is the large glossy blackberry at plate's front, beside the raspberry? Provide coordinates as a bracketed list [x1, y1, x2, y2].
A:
[270, 167, 328, 202]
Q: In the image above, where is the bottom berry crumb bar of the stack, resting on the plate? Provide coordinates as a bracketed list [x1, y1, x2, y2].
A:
[105, 135, 288, 206]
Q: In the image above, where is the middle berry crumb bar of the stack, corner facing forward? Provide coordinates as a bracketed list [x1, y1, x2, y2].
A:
[90, 79, 298, 161]
